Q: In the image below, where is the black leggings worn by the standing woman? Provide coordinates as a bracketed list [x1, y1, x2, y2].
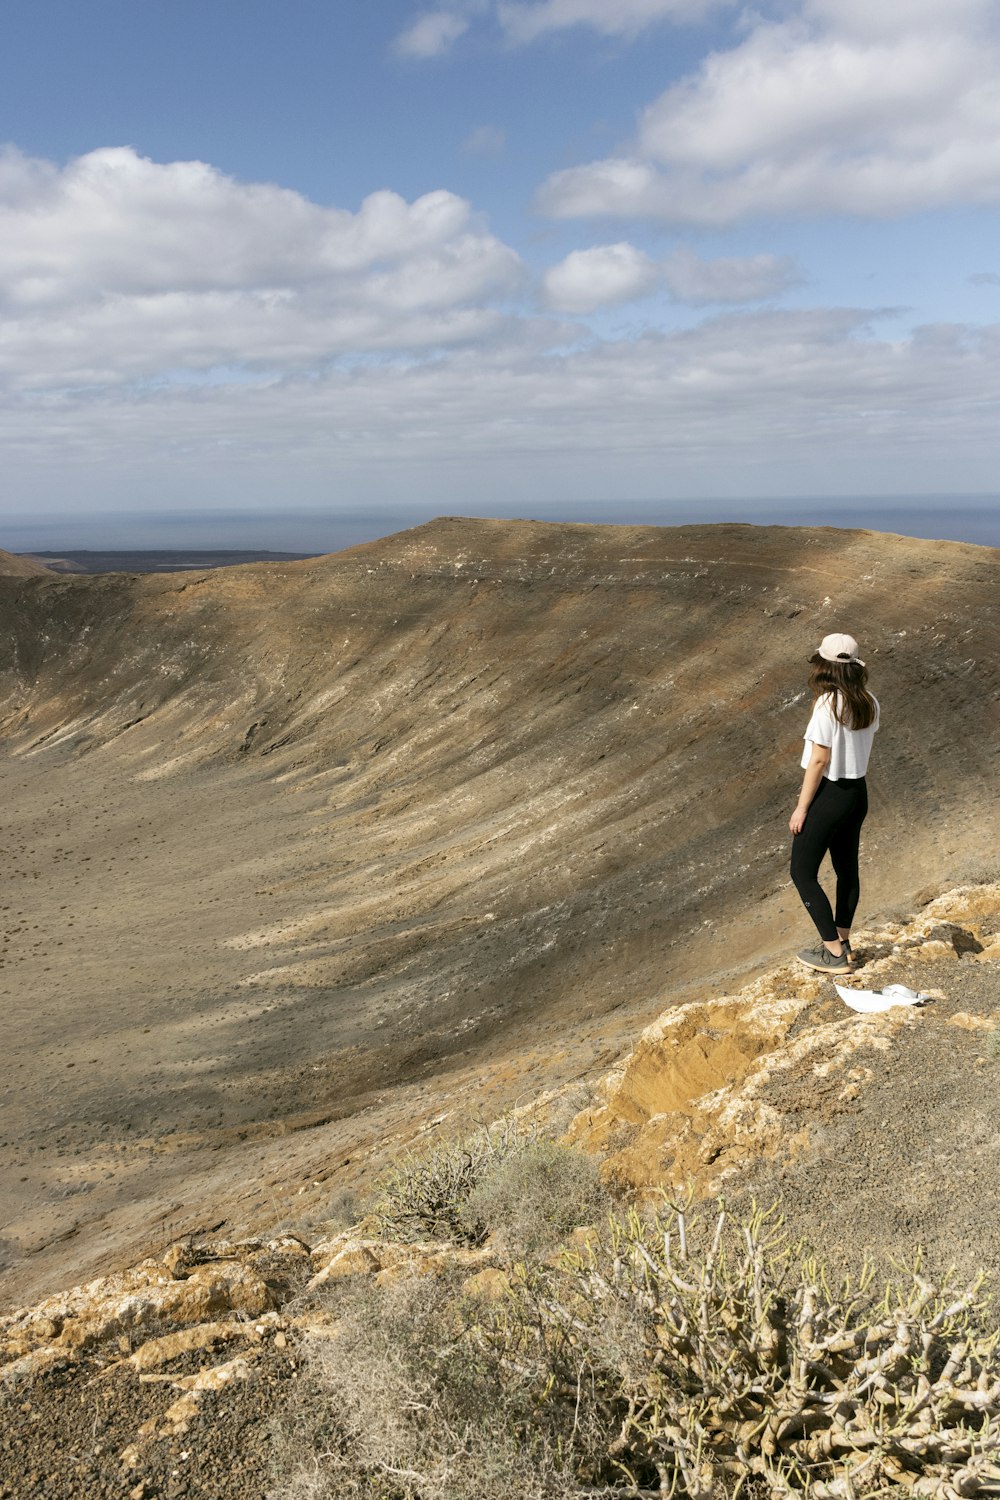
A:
[792, 776, 868, 942]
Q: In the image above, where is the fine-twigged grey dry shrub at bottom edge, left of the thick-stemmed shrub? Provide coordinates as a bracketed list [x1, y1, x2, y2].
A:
[271, 1277, 577, 1500]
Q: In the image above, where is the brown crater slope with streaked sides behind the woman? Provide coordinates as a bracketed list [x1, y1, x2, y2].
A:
[0, 519, 1000, 1314]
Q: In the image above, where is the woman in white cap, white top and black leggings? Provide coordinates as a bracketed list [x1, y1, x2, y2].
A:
[789, 635, 879, 974]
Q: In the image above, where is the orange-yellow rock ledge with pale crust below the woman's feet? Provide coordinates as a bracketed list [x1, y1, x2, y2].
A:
[568, 884, 1000, 1197]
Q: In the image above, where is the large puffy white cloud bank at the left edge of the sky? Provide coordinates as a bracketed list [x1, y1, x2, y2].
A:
[0, 147, 522, 389]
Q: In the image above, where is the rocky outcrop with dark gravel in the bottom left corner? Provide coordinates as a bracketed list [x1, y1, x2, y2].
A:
[0, 1232, 505, 1500]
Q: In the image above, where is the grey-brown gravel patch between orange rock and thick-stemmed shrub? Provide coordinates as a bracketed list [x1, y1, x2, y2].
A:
[732, 956, 1000, 1278]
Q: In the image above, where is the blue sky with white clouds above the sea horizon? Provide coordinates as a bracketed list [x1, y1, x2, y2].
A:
[0, 0, 1000, 545]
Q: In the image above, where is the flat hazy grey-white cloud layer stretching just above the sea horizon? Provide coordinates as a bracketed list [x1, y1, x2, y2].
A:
[7, 311, 1000, 510]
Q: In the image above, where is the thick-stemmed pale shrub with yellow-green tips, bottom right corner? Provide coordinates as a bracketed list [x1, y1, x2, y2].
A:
[491, 1211, 1000, 1500]
